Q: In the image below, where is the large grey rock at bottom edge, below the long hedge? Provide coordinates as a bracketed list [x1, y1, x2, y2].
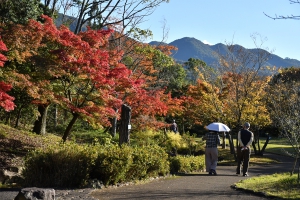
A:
[14, 187, 55, 200]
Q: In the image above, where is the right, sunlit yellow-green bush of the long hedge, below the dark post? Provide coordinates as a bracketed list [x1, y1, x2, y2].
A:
[91, 145, 169, 185]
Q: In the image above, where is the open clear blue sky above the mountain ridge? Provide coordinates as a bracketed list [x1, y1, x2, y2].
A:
[140, 0, 300, 60]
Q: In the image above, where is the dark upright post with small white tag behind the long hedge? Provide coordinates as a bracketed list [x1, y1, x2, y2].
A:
[119, 104, 131, 146]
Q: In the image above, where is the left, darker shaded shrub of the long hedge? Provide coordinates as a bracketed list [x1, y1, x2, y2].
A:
[23, 143, 95, 187]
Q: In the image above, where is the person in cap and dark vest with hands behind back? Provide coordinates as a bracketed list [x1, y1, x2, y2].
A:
[236, 122, 254, 176]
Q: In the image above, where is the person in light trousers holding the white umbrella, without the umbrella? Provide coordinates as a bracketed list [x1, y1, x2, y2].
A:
[203, 130, 221, 175]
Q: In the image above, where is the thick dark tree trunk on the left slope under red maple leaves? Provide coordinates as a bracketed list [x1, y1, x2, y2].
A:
[33, 104, 50, 135]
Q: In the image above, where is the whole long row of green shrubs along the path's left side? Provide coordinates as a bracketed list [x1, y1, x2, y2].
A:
[23, 136, 170, 187]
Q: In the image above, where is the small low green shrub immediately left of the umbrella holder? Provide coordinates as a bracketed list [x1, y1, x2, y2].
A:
[170, 155, 205, 174]
